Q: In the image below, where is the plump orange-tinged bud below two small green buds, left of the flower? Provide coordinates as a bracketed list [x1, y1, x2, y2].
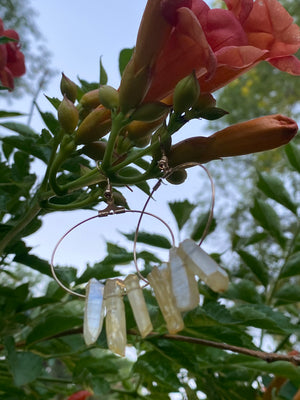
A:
[76, 106, 111, 144]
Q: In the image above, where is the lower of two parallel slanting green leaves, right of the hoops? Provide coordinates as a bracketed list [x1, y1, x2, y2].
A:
[250, 198, 286, 247]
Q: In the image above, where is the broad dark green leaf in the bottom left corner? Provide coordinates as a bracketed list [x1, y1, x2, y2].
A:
[5, 337, 43, 386]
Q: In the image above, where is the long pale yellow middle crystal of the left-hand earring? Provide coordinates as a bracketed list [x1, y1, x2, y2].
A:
[104, 279, 126, 357]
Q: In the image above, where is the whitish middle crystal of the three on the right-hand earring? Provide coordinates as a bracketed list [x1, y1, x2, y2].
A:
[169, 248, 199, 311]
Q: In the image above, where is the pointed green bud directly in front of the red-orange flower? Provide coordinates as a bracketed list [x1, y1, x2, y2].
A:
[173, 71, 200, 114]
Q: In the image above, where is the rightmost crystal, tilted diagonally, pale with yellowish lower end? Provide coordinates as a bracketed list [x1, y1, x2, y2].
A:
[178, 239, 229, 292]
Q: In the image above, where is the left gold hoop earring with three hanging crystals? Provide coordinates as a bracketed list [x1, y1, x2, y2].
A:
[50, 192, 175, 356]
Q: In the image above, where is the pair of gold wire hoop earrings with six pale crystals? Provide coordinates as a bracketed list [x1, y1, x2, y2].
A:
[50, 155, 229, 356]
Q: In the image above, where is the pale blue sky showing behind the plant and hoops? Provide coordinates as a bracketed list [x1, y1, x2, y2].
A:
[1, 0, 218, 269]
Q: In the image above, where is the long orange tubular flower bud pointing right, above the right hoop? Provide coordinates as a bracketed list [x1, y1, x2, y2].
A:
[168, 114, 298, 167]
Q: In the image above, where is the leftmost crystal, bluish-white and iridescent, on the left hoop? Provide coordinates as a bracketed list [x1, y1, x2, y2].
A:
[83, 278, 105, 346]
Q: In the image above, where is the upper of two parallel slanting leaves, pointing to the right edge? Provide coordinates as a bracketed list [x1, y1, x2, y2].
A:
[257, 172, 297, 215]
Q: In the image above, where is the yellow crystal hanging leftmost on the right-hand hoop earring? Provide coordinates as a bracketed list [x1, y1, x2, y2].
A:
[147, 263, 184, 334]
